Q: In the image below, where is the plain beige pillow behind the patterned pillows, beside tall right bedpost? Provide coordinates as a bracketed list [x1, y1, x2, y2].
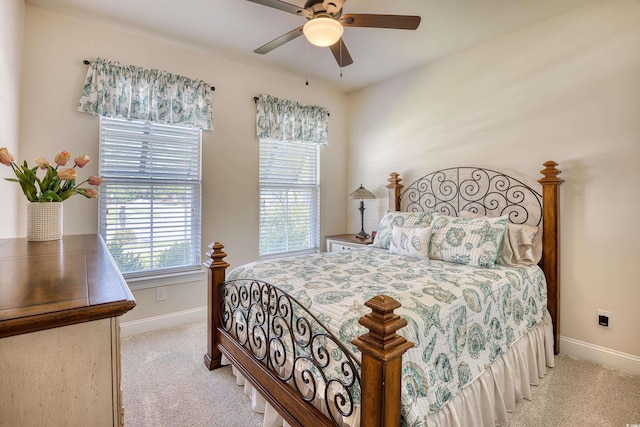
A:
[458, 211, 542, 267]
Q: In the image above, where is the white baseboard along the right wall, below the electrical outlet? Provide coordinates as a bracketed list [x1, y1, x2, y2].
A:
[560, 336, 640, 375]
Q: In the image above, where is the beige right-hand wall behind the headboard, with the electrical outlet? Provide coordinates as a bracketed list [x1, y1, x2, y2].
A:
[348, 0, 640, 356]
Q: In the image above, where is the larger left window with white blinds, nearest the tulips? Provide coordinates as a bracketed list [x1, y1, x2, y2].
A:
[98, 117, 201, 278]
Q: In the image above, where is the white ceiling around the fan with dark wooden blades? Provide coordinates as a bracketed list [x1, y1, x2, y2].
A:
[25, 0, 597, 92]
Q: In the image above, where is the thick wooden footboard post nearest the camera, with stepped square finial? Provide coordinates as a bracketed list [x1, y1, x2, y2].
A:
[351, 295, 413, 427]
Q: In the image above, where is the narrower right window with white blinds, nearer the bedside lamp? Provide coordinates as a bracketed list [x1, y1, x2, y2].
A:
[259, 140, 320, 255]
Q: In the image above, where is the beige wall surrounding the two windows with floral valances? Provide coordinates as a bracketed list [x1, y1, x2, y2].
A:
[15, 6, 347, 322]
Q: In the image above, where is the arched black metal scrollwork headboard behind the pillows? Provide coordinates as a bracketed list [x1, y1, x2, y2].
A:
[400, 167, 542, 226]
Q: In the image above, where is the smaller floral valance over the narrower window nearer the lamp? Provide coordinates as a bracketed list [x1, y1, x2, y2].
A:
[256, 95, 329, 145]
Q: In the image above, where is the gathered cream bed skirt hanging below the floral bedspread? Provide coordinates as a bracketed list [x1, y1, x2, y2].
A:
[222, 313, 554, 427]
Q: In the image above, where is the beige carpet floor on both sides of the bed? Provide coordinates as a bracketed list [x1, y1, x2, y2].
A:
[122, 322, 640, 427]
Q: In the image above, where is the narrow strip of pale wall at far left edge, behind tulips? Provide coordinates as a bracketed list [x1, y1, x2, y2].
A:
[0, 0, 25, 238]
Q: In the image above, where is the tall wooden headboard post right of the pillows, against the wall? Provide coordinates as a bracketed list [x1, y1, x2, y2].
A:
[538, 160, 564, 354]
